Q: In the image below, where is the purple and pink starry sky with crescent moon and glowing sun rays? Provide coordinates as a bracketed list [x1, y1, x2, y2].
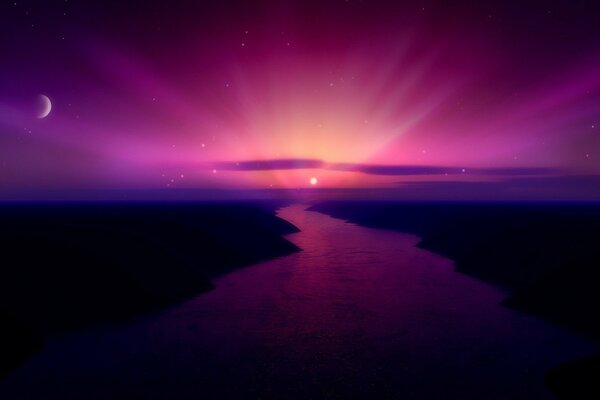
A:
[0, 0, 600, 200]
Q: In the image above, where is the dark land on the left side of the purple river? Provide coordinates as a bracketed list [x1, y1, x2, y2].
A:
[0, 203, 298, 378]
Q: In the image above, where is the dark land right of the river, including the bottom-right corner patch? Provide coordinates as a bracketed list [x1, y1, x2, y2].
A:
[311, 201, 600, 399]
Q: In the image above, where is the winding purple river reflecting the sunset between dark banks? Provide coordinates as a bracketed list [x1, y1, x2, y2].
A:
[0, 205, 596, 399]
